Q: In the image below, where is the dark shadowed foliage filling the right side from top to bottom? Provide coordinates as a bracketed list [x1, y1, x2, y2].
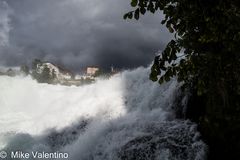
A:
[123, 0, 240, 159]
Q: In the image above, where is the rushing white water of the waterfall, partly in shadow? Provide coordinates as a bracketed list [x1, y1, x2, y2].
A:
[0, 68, 206, 160]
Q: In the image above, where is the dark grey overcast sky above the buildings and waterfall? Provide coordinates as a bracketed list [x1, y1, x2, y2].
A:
[0, 0, 171, 71]
